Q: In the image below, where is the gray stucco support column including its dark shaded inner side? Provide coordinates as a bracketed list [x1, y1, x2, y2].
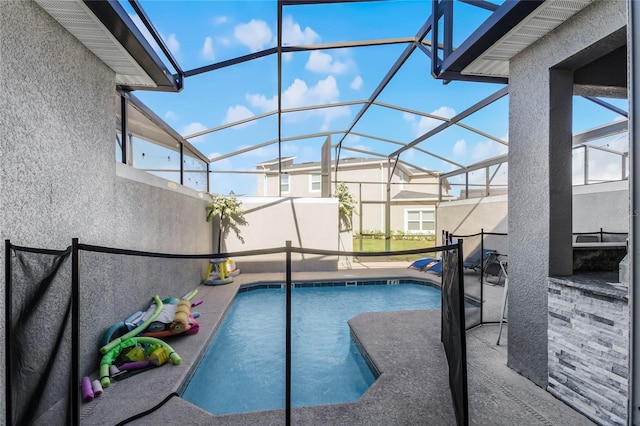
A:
[508, 65, 573, 388]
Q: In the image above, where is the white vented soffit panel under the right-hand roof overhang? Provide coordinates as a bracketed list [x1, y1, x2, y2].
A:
[462, 0, 593, 77]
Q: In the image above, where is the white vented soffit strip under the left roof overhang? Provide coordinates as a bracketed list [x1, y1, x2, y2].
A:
[36, 0, 157, 87]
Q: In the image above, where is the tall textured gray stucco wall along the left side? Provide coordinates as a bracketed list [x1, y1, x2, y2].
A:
[0, 1, 211, 418]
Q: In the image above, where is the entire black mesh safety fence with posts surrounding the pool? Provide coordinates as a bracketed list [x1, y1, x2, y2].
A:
[5, 239, 468, 425]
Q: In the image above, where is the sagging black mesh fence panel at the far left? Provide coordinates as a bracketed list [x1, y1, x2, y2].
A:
[5, 240, 77, 425]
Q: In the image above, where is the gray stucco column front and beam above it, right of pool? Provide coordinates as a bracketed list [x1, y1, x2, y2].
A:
[508, 1, 627, 387]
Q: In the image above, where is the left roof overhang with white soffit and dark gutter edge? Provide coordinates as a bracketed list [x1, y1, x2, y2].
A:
[35, 0, 182, 91]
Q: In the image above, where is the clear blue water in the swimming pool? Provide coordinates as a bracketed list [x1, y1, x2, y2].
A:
[183, 284, 441, 414]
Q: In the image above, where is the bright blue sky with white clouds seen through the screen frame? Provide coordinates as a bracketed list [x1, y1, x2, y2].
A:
[126, 0, 626, 194]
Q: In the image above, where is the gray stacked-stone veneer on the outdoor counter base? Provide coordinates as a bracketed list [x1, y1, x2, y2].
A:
[548, 277, 629, 425]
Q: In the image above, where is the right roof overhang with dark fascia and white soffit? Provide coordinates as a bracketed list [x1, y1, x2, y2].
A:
[438, 0, 593, 83]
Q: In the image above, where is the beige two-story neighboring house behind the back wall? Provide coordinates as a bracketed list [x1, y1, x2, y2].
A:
[256, 157, 448, 235]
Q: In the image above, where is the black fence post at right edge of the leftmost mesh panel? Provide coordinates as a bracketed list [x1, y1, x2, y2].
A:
[69, 238, 80, 426]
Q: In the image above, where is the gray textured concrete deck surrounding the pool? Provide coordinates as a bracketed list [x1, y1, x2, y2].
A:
[80, 262, 594, 426]
